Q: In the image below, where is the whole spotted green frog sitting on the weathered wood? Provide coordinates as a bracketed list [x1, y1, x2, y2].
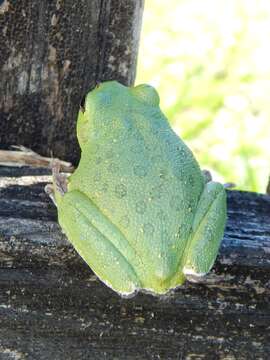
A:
[56, 81, 226, 296]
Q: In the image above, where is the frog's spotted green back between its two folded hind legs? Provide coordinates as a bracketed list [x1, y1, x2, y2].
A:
[69, 82, 203, 292]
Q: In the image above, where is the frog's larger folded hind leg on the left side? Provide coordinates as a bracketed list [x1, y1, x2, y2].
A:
[58, 191, 139, 295]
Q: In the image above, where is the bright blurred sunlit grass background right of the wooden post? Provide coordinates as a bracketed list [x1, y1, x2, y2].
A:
[136, 0, 270, 193]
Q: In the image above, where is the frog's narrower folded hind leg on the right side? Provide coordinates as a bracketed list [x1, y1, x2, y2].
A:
[183, 181, 227, 276]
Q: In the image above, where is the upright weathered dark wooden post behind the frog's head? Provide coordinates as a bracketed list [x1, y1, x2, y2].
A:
[0, 0, 143, 163]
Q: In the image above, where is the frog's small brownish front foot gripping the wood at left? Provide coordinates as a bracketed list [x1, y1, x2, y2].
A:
[45, 160, 67, 206]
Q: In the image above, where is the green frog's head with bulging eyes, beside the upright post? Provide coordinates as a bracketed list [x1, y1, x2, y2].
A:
[77, 81, 159, 147]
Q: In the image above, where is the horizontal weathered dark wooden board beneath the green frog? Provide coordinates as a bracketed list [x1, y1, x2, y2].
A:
[0, 167, 270, 360]
